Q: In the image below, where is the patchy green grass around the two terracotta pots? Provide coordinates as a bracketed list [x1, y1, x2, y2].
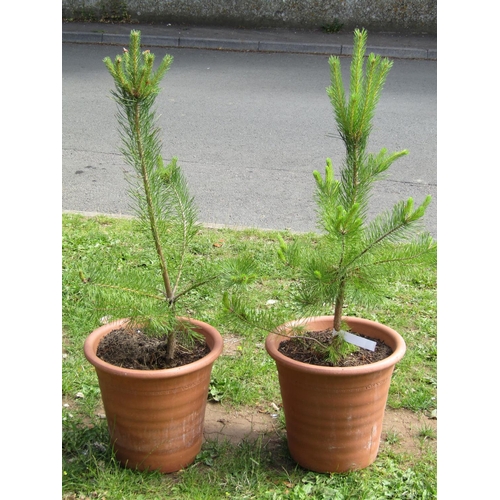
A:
[62, 214, 437, 500]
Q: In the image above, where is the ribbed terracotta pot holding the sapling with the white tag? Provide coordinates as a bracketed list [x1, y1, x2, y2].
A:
[266, 316, 406, 472]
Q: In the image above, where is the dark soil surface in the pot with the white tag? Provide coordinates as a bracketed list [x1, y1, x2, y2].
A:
[278, 328, 393, 367]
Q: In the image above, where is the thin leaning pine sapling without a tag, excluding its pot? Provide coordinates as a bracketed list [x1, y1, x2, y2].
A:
[82, 30, 234, 359]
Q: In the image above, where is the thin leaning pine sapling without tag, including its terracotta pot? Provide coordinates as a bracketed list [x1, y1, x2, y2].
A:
[81, 31, 248, 473]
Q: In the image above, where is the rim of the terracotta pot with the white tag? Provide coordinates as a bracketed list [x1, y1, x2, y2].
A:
[265, 315, 406, 376]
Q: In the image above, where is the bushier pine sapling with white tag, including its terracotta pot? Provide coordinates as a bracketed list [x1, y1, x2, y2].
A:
[225, 30, 436, 472]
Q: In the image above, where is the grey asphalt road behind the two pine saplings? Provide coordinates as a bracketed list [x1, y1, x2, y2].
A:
[62, 43, 437, 237]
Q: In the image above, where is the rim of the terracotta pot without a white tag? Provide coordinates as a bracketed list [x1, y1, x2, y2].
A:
[83, 316, 224, 379]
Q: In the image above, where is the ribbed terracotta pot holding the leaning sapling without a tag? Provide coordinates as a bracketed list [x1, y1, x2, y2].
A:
[84, 318, 223, 473]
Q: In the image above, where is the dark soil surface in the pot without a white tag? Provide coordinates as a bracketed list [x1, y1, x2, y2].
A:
[96, 328, 210, 370]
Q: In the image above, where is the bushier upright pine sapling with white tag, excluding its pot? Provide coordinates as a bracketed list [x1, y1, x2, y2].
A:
[225, 30, 436, 362]
